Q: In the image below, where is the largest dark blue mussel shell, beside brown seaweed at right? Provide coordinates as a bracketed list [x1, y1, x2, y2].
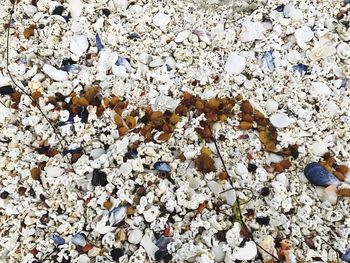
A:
[304, 162, 340, 186]
